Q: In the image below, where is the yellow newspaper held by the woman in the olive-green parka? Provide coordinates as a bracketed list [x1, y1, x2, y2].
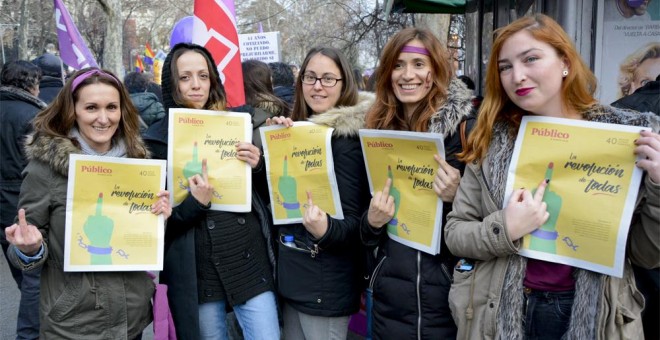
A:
[64, 155, 165, 272]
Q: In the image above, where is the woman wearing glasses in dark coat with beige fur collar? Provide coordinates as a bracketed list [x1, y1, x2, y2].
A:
[272, 47, 374, 340]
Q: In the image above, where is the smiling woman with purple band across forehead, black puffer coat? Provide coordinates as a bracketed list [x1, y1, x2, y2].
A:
[360, 28, 474, 340]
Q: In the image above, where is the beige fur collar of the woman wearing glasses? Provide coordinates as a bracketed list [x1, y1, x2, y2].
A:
[307, 92, 376, 137]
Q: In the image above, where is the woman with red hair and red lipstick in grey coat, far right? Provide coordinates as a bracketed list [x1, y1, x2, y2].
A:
[445, 15, 660, 339]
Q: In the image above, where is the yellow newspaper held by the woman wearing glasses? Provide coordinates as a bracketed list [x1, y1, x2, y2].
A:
[259, 122, 344, 224]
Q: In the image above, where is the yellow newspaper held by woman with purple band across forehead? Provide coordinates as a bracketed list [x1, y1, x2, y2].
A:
[360, 130, 445, 255]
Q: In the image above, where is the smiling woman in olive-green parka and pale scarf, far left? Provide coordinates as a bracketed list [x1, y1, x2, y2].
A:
[6, 68, 172, 339]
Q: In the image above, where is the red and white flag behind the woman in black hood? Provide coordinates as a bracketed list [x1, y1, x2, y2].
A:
[193, 0, 245, 107]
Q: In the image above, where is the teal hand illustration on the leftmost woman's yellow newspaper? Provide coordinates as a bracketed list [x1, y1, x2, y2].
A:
[83, 192, 115, 265]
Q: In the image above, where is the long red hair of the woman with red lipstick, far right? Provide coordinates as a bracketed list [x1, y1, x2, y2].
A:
[458, 14, 597, 162]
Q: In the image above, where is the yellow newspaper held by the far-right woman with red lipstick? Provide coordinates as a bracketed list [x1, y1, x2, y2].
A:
[505, 116, 649, 277]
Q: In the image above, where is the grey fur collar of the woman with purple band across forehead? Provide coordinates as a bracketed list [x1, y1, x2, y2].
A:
[429, 78, 473, 137]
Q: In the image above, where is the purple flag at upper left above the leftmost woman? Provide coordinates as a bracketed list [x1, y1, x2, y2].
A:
[54, 0, 98, 70]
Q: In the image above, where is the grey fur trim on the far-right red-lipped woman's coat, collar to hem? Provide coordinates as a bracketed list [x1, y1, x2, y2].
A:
[486, 105, 660, 340]
